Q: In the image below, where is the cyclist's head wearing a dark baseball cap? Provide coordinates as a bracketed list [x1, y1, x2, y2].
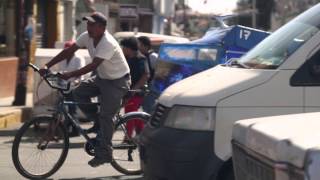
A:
[82, 12, 107, 38]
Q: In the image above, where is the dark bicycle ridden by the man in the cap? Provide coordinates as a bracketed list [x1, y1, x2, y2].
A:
[12, 63, 150, 179]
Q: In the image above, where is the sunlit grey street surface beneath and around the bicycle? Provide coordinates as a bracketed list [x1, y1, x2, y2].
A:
[0, 124, 143, 180]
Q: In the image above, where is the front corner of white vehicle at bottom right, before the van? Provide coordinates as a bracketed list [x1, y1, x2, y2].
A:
[232, 112, 320, 180]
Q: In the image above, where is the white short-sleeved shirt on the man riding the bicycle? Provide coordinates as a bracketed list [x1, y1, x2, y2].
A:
[76, 31, 130, 80]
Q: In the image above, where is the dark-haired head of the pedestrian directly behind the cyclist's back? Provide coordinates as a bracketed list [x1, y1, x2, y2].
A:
[120, 37, 139, 58]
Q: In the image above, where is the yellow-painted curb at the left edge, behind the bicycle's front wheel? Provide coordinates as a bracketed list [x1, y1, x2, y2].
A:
[0, 106, 31, 129]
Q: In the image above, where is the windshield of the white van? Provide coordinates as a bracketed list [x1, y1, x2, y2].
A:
[238, 5, 320, 69]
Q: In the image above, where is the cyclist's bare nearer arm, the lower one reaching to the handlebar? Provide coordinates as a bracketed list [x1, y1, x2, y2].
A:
[61, 57, 104, 79]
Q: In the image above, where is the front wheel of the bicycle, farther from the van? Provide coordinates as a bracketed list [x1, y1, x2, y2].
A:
[12, 116, 69, 179]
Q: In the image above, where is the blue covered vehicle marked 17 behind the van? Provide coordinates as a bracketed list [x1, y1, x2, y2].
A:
[152, 25, 270, 93]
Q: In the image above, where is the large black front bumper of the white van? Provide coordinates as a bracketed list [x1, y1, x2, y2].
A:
[141, 126, 223, 180]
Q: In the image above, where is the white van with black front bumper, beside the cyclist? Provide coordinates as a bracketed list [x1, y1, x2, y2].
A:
[141, 4, 320, 180]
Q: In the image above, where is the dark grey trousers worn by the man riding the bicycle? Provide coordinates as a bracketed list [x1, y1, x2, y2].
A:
[73, 75, 131, 157]
